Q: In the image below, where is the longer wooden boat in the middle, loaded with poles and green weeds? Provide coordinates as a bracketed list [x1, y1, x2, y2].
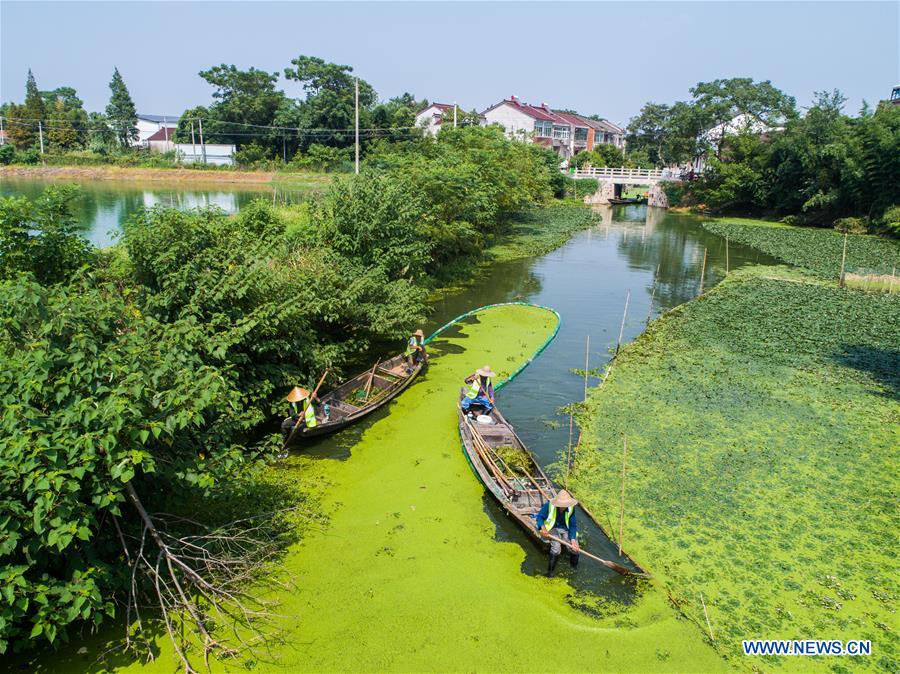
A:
[457, 398, 646, 576]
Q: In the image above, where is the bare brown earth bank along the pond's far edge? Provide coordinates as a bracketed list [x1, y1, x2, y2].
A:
[0, 166, 333, 188]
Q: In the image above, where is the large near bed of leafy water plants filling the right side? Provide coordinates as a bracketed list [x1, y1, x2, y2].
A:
[572, 268, 900, 674]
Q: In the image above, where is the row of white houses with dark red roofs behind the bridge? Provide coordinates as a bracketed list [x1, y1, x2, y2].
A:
[481, 96, 625, 160]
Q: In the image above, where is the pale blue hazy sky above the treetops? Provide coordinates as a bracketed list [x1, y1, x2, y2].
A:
[0, 0, 900, 122]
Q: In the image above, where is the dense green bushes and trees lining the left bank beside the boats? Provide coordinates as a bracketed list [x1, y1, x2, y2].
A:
[0, 128, 588, 651]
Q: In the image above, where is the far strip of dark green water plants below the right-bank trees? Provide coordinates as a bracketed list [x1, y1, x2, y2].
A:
[703, 218, 900, 280]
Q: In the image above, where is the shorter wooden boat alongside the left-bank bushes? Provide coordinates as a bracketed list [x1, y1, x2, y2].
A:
[282, 354, 425, 446]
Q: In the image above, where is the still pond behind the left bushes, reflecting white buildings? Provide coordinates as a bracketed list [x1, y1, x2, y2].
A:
[0, 177, 309, 248]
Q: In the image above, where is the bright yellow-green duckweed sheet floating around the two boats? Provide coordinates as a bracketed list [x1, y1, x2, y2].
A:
[47, 306, 725, 672]
